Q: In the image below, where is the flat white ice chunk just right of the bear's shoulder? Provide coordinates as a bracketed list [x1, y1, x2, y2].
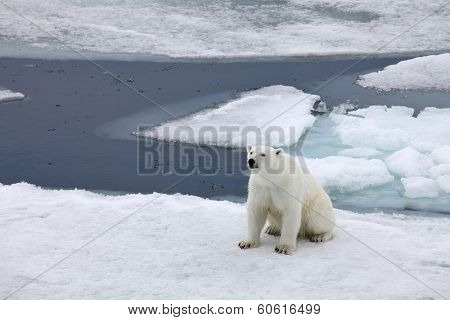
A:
[305, 156, 394, 191]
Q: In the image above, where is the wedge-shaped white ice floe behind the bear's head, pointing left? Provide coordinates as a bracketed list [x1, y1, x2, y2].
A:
[138, 85, 320, 147]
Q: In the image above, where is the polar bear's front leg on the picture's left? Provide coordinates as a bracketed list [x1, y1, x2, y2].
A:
[239, 203, 267, 249]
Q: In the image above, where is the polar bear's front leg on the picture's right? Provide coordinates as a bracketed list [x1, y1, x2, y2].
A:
[275, 207, 302, 254]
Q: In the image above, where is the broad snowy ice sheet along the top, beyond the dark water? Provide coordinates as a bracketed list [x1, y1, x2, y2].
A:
[0, 0, 450, 59]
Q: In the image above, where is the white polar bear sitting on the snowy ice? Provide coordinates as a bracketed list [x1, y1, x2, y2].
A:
[239, 146, 335, 254]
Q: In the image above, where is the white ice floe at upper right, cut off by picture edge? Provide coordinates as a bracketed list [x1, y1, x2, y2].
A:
[356, 53, 450, 91]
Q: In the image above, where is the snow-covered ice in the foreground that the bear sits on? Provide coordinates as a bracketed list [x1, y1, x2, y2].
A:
[0, 183, 450, 299]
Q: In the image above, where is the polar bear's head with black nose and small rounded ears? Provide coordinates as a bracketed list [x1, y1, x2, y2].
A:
[247, 146, 284, 174]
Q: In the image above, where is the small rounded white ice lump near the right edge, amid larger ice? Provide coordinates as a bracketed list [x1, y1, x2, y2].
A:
[385, 147, 434, 177]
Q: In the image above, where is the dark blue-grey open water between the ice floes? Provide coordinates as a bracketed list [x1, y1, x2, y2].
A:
[0, 58, 450, 201]
